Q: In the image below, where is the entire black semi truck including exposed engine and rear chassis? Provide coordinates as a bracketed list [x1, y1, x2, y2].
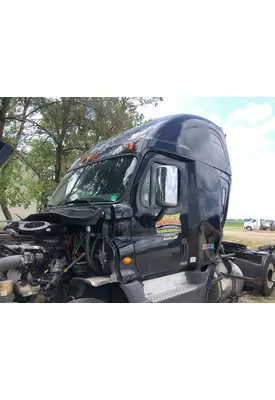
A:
[0, 114, 275, 303]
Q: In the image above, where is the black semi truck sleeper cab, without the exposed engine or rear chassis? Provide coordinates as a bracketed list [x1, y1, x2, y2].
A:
[21, 114, 239, 301]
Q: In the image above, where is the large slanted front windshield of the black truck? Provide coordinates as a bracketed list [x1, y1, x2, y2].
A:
[48, 155, 137, 206]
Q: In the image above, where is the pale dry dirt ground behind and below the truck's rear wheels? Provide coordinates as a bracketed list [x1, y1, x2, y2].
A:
[224, 227, 275, 303]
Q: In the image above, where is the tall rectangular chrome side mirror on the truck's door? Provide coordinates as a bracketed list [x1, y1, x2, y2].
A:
[156, 165, 179, 208]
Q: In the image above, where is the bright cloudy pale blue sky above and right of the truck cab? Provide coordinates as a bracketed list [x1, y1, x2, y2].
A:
[142, 97, 275, 219]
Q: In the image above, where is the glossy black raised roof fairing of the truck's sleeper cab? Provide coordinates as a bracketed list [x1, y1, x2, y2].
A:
[71, 114, 231, 175]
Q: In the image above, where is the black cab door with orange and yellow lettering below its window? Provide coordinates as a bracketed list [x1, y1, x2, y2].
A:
[132, 153, 188, 278]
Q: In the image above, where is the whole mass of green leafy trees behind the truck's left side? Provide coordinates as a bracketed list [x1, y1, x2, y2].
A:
[0, 97, 162, 219]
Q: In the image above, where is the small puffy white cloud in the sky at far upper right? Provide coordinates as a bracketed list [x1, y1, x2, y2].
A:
[228, 103, 272, 125]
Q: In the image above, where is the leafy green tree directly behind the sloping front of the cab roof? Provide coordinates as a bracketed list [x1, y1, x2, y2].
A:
[28, 97, 160, 184]
